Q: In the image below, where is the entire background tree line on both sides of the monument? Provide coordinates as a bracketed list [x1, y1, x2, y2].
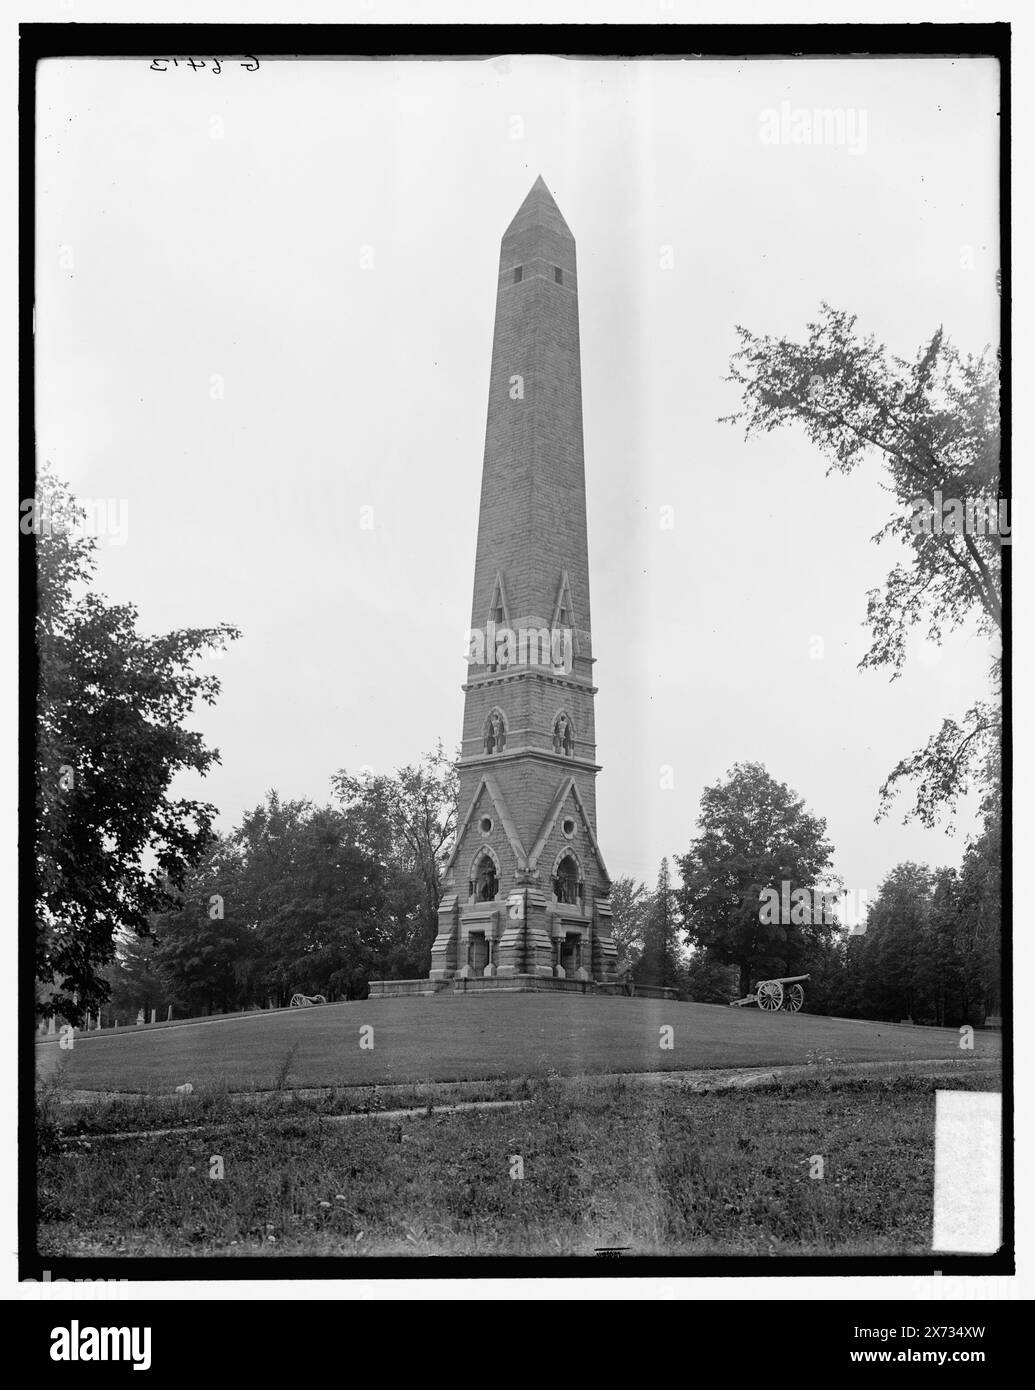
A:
[84, 746, 1002, 1027]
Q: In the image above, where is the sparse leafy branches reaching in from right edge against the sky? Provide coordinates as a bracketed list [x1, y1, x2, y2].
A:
[725, 303, 1003, 826]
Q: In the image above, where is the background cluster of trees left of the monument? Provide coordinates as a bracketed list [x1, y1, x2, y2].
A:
[93, 745, 456, 1019]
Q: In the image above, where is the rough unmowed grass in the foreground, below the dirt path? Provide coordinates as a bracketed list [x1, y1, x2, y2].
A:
[39, 1061, 999, 1258]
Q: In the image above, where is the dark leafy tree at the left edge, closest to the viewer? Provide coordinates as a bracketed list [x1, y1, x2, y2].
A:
[33, 470, 239, 1023]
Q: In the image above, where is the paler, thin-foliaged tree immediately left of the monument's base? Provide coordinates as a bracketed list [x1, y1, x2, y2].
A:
[331, 742, 460, 976]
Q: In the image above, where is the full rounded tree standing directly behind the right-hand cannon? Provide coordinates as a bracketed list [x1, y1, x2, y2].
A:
[675, 763, 834, 997]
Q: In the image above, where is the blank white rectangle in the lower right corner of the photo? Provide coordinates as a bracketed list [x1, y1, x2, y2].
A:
[931, 1091, 1003, 1255]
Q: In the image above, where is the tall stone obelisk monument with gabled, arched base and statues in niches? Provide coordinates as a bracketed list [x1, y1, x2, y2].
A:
[431, 178, 615, 990]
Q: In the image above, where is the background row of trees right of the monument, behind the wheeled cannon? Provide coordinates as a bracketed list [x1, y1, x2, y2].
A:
[611, 763, 1002, 1027]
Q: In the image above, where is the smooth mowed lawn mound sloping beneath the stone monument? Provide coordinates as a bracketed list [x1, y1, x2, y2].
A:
[36, 994, 1000, 1093]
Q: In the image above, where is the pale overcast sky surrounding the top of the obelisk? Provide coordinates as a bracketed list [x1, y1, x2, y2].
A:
[36, 57, 999, 911]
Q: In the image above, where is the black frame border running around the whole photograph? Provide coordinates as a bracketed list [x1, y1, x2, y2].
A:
[18, 22, 1014, 1280]
